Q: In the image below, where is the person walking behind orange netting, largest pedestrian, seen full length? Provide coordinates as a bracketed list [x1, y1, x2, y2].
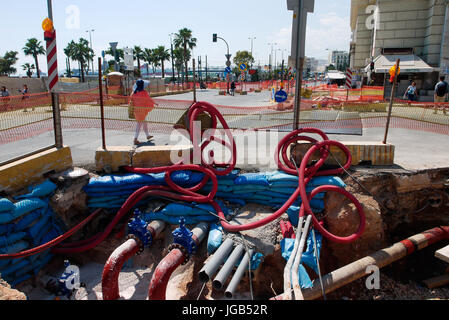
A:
[131, 79, 157, 145]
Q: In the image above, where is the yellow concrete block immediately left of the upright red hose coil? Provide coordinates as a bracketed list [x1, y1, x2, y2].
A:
[132, 145, 193, 168]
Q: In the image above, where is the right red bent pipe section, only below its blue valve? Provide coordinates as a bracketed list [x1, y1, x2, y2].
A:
[148, 248, 185, 300]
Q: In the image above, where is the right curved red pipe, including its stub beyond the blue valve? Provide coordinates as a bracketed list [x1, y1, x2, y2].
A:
[148, 222, 209, 300]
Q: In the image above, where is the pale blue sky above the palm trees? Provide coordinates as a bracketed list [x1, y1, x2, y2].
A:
[0, 0, 351, 75]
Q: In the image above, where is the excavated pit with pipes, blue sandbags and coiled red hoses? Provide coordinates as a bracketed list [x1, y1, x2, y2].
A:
[0, 102, 449, 300]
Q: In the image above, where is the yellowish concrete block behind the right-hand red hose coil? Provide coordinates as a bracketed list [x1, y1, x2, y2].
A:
[292, 141, 395, 166]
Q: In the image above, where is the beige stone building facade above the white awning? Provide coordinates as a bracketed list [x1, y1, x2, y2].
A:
[351, 0, 449, 69]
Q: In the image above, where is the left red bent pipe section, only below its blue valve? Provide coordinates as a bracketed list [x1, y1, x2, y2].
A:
[101, 239, 140, 300]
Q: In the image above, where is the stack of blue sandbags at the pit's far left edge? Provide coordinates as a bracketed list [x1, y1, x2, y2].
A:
[0, 180, 63, 286]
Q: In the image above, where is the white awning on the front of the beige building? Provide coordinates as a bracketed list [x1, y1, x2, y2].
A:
[365, 54, 435, 73]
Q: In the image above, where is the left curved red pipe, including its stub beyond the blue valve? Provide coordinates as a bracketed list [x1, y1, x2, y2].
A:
[101, 220, 165, 300]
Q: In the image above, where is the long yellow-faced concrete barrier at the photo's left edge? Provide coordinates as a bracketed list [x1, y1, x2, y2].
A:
[0, 147, 73, 193]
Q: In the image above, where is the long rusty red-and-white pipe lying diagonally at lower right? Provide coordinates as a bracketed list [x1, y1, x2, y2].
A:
[270, 226, 449, 300]
